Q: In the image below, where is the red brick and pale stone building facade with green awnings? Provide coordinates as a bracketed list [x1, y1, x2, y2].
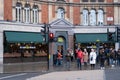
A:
[0, 0, 120, 72]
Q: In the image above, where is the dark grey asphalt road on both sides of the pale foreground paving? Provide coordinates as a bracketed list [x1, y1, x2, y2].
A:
[0, 68, 120, 80]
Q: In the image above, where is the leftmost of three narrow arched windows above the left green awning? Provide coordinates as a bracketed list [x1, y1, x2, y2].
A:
[16, 2, 22, 22]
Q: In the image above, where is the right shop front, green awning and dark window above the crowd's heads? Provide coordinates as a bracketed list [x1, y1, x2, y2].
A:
[74, 33, 115, 53]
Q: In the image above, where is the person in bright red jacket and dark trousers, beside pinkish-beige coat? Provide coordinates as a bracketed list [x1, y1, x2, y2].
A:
[76, 49, 83, 70]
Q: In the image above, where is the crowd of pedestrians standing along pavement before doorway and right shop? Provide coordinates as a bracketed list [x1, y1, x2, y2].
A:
[54, 48, 120, 70]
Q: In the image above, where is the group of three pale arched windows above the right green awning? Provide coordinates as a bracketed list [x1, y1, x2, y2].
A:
[81, 8, 104, 26]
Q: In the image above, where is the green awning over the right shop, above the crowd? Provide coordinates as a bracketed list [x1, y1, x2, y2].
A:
[75, 33, 108, 43]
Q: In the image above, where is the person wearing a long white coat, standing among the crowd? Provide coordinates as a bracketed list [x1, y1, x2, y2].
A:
[89, 49, 97, 69]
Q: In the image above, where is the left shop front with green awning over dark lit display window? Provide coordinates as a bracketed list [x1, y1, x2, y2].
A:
[3, 31, 48, 63]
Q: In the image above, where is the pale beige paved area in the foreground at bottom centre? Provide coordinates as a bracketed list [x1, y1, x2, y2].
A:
[27, 70, 105, 80]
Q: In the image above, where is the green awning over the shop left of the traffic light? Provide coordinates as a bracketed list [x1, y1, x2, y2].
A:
[5, 31, 44, 43]
